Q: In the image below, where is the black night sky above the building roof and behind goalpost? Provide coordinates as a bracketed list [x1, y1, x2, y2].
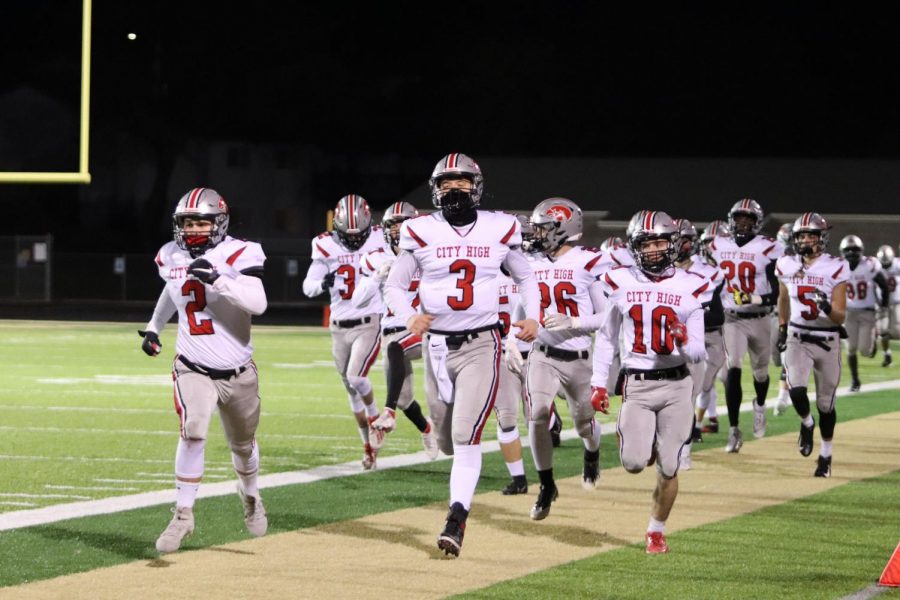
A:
[7, 0, 900, 157]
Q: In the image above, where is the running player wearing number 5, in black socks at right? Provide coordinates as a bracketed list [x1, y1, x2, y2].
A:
[776, 213, 849, 477]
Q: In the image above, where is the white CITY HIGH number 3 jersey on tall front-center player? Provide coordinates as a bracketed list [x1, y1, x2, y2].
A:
[400, 210, 522, 331]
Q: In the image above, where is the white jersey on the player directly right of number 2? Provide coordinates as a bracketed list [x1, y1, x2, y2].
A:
[312, 226, 384, 321]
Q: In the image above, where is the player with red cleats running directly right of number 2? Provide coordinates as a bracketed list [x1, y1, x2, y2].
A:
[303, 194, 384, 470]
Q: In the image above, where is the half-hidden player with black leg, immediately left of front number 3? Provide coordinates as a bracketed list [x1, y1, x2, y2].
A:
[350, 202, 439, 460]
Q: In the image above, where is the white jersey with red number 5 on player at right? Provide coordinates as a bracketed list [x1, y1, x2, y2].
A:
[775, 254, 850, 331]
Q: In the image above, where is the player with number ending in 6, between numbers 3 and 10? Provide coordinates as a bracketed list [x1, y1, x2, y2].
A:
[525, 198, 604, 520]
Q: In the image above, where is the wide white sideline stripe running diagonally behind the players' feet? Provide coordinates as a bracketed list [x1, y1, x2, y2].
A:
[0, 380, 900, 531]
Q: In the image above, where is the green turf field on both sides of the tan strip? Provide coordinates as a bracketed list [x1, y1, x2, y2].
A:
[0, 321, 900, 598]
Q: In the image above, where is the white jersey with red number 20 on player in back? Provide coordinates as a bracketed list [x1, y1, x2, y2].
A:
[709, 235, 784, 312]
